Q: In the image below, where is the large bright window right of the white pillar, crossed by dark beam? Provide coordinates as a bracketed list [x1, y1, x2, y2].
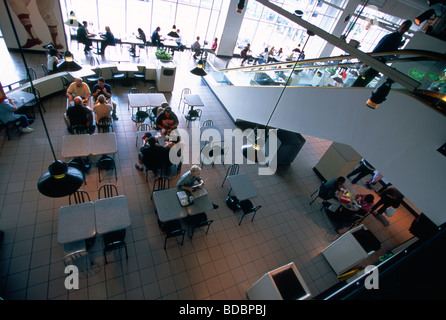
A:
[234, 0, 345, 58]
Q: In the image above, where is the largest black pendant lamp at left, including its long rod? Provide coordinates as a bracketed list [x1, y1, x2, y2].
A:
[4, 0, 84, 198]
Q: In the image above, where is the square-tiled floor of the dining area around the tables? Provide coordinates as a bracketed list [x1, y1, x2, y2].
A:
[0, 41, 414, 300]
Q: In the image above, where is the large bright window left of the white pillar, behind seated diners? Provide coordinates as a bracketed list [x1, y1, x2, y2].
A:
[60, 0, 222, 45]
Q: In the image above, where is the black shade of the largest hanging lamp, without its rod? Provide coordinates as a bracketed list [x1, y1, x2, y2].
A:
[37, 160, 84, 198]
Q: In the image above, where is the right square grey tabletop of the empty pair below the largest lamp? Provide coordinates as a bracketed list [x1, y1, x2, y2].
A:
[94, 195, 130, 234]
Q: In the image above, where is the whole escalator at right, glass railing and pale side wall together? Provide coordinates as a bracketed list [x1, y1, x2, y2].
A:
[204, 50, 446, 225]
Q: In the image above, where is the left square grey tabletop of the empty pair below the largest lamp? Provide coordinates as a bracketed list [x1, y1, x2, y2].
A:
[57, 201, 96, 243]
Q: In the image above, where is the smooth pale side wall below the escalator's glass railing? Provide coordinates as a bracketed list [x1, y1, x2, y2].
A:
[208, 82, 446, 225]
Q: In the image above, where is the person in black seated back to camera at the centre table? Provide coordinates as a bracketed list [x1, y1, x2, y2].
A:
[135, 132, 168, 177]
